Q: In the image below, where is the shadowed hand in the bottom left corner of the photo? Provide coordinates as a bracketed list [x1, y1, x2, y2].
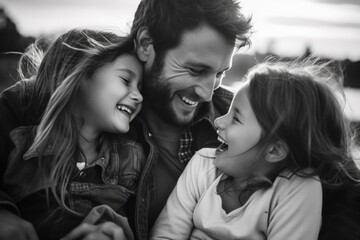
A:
[0, 208, 39, 240]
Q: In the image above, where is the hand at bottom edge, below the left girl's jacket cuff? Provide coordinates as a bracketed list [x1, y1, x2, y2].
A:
[61, 222, 127, 240]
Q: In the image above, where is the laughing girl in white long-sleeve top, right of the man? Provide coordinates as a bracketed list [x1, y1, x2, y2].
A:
[151, 58, 359, 240]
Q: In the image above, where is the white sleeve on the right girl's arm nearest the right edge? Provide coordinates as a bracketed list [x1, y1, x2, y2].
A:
[267, 176, 322, 240]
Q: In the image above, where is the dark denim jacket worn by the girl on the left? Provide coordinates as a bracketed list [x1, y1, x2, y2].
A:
[0, 79, 145, 239]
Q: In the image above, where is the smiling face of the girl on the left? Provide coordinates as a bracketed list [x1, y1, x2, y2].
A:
[76, 54, 143, 135]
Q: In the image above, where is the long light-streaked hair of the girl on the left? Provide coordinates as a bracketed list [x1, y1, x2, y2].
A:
[20, 29, 134, 214]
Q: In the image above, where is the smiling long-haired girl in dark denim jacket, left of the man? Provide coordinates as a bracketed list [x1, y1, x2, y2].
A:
[0, 29, 145, 239]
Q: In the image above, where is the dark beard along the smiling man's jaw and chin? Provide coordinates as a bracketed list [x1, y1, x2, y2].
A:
[143, 55, 202, 126]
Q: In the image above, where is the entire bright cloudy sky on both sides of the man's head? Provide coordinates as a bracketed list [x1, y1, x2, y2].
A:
[0, 0, 360, 61]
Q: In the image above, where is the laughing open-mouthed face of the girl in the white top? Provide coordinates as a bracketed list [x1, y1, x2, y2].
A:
[215, 86, 265, 178]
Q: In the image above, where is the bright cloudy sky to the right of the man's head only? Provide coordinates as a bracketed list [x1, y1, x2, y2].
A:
[239, 0, 360, 60]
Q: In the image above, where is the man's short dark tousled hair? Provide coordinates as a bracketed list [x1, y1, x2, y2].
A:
[131, 0, 251, 54]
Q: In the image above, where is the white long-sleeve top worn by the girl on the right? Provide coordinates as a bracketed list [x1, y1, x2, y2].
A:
[151, 148, 322, 240]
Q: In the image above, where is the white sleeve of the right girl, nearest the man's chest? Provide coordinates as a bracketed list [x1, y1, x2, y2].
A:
[150, 153, 210, 240]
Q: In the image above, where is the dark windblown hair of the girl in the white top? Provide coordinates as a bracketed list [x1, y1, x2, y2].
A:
[247, 56, 360, 186]
